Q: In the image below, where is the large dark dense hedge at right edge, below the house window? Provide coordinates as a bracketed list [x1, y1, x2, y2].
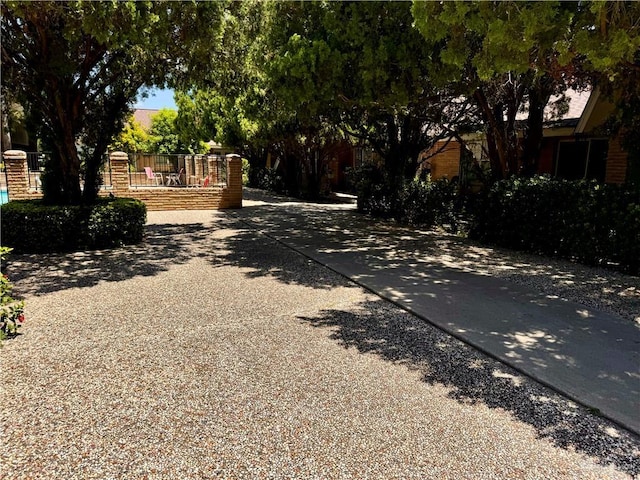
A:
[469, 176, 640, 274]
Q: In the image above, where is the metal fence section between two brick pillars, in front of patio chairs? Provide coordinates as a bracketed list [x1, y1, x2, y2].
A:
[129, 153, 227, 188]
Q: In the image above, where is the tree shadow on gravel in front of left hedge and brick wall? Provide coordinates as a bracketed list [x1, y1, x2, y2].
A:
[4, 212, 345, 297]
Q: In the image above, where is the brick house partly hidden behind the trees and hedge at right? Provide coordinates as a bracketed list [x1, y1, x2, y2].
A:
[421, 88, 627, 183]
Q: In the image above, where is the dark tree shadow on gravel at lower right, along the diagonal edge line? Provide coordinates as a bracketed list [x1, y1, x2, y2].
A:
[299, 300, 640, 476]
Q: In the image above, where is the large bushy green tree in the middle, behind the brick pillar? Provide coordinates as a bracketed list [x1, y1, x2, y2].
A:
[208, 2, 468, 193]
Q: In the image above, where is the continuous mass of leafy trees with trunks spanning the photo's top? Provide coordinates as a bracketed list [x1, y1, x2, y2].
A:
[1, 0, 640, 203]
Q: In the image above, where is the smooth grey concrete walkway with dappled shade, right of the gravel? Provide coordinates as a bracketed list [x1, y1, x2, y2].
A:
[237, 191, 640, 433]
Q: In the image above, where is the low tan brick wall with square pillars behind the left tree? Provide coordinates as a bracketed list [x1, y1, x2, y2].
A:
[3, 150, 242, 210]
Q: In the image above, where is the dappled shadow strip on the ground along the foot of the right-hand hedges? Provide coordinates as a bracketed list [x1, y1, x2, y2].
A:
[237, 189, 640, 322]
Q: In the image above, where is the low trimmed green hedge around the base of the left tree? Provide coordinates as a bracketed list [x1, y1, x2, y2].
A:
[0, 198, 147, 253]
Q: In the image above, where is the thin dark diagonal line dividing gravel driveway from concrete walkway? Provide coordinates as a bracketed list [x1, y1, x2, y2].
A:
[236, 216, 640, 437]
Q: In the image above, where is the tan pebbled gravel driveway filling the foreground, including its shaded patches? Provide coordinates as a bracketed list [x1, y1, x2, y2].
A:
[0, 204, 640, 479]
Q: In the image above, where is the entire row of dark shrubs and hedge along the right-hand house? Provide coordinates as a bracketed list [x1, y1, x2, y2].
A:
[354, 165, 640, 275]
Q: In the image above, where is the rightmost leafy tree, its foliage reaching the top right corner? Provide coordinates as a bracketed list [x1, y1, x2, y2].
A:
[413, 1, 640, 182]
